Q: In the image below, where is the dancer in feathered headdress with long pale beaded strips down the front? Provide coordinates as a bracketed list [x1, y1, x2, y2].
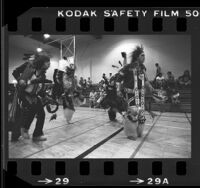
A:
[115, 46, 153, 140]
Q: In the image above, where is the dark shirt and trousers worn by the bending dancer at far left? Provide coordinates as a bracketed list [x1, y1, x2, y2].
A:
[13, 62, 46, 139]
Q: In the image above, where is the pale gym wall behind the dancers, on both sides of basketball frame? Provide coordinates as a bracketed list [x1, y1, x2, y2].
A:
[9, 35, 191, 83]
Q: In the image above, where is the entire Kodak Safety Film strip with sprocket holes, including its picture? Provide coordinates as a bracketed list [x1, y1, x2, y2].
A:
[2, 7, 200, 186]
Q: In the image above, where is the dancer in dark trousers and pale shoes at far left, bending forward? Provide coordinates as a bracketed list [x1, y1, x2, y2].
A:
[12, 55, 50, 141]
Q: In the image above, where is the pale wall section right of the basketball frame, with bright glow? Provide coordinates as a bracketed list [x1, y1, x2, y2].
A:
[74, 35, 191, 82]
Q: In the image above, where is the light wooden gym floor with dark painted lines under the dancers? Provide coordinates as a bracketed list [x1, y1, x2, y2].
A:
[8, 107, 191, 158]
